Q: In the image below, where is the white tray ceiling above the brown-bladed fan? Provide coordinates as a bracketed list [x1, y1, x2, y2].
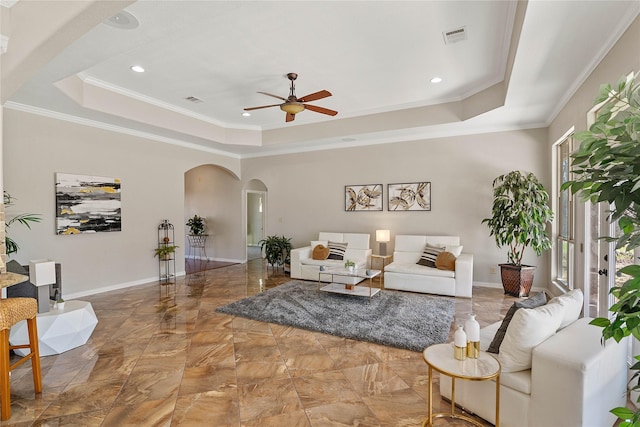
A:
[5, 0, 640, 156]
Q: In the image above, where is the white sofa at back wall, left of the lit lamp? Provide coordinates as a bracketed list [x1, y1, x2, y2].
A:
[291, 232, 371, 284]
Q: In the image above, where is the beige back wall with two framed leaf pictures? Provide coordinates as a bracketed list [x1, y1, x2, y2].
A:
[242, 129, 550, 287]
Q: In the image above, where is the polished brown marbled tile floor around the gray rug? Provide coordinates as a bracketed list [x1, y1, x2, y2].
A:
[1, 260, 515, 427]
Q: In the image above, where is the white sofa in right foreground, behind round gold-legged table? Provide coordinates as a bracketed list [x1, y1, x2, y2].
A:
[440, 294, 628, 427]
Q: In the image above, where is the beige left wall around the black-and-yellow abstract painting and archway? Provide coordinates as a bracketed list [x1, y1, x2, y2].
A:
[3, 108, 240, 296]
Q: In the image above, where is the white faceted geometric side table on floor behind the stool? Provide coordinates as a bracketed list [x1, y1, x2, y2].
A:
[9, 300, 98, 356]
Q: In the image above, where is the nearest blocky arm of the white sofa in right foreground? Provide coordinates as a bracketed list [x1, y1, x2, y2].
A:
[530, 318, 627, 427]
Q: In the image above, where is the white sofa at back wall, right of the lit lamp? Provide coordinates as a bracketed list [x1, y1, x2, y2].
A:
[384, 235, 473, 298]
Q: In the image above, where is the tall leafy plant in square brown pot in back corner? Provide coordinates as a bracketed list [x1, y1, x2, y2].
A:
[482, 171, 553, 297]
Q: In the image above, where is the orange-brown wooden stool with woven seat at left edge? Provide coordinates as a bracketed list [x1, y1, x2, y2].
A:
[0, 298, 42, 421]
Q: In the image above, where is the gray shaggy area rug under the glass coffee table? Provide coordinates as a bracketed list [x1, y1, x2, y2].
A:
[216, 280, 454, 351]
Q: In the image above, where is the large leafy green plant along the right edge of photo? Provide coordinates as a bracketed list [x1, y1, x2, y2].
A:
[561, 74, 640, 427]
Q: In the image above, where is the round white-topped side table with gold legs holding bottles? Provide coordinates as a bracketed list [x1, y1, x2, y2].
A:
[422, 343, 500, 427]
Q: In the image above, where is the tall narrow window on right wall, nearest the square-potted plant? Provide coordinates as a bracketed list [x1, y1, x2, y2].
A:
[553, 134, 574, 289]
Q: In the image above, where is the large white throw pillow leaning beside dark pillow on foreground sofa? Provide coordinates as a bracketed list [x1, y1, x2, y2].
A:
[498, 304, 564, 372]
